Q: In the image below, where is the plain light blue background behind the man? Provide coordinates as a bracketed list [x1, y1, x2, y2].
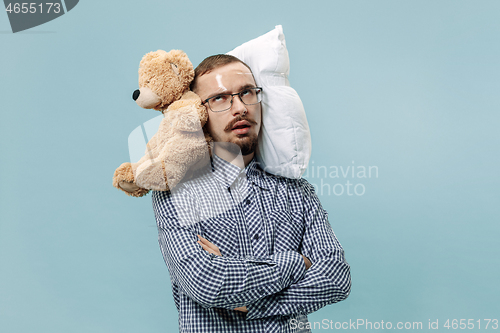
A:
[0, 0, 500, 333]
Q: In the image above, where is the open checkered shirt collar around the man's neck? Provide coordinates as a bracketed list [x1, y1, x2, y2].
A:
[211, 154, 270, 190]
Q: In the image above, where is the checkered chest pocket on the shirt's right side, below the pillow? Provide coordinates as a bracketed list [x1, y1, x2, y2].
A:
[269, 210, 304, 253]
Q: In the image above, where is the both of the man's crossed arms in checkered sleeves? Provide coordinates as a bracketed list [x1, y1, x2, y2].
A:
[153, 180, 351, 320]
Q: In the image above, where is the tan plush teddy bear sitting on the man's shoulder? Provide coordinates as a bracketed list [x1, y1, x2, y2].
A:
[113, 50, 212, 197]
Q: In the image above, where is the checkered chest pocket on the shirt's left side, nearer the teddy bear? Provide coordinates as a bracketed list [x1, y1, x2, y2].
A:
[201, 217, 237, 256]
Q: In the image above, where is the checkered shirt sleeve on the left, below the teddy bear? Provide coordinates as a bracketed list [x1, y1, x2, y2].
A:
[153, 187, 306, 310]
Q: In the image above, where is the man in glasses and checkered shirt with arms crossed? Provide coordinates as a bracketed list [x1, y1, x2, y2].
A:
[153, 55, 351, 333]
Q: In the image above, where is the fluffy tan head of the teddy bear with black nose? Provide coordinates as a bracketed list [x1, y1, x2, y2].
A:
[133, 50, 194, 111]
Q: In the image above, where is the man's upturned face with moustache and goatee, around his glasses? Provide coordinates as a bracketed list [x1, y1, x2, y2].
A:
[195, 62, 262, 155]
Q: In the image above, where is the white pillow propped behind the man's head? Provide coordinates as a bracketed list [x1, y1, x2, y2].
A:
[227, 25, 311, 178]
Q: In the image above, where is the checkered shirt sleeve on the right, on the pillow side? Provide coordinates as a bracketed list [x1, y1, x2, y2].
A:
[246, 179, 351, 320]
